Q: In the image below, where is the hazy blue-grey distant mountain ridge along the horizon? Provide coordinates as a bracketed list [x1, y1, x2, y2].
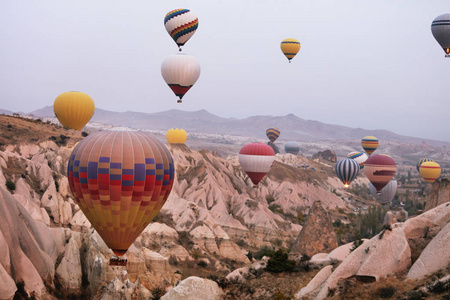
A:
[30, 106, 450, 146]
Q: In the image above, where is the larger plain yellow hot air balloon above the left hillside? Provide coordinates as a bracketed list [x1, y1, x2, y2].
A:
[53, 92, 95, 130]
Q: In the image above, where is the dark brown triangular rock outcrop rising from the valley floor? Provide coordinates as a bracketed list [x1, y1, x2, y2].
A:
[289, 201, 338, 258]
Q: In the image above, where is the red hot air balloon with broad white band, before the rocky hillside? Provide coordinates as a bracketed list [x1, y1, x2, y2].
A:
[239, 143, 275, 187]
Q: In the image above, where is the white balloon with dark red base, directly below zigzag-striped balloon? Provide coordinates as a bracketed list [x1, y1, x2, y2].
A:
[161, 53, 200, 103]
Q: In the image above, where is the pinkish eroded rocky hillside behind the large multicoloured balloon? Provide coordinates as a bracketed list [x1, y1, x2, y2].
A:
[0, 116, 367, 299]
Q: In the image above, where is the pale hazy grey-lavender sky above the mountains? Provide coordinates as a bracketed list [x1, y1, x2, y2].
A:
[0, 0, 450, 141]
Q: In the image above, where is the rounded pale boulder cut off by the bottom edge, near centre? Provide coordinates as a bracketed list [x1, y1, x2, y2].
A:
[161, 276, 224, 300]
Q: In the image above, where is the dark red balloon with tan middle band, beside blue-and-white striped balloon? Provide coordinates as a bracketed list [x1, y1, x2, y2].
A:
[364, 154, 397, 193]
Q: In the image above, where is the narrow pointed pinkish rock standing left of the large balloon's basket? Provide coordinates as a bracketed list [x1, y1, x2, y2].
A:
[55, 232, 83, 295]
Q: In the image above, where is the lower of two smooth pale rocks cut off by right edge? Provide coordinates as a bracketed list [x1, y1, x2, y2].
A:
[407, 223, 450, 279]
